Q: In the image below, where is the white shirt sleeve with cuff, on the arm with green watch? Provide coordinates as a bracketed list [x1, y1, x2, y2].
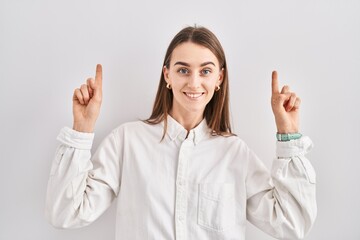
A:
[247, 137, 317, 239]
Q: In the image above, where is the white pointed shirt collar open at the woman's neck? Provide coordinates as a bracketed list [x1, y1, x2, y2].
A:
[167, 115, 211, 145]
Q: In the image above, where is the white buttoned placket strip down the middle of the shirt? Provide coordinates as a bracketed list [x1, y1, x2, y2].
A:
[175, 136, 192, 240]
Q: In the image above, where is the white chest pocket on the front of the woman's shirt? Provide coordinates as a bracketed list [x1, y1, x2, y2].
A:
[198, 183, 235, 232]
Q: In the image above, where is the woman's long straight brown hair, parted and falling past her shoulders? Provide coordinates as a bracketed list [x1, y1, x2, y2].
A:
[145, 27, 233, 139]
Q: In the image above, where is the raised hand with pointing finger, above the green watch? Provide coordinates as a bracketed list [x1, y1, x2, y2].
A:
[271, 71, 301, 133]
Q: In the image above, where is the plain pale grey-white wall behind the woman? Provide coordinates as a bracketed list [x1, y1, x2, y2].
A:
[0, 0, 360, 240]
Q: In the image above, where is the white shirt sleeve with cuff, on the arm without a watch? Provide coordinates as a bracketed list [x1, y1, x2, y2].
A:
[45, 127, 121, 228]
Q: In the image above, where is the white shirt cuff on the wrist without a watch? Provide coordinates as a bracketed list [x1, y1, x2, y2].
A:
[56, 127, 95, 150]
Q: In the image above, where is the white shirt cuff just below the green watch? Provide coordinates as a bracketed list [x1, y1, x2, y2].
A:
[276, 136, 314, 158]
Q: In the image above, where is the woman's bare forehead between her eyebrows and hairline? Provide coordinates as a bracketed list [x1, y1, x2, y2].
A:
[171, 42, 219, 66]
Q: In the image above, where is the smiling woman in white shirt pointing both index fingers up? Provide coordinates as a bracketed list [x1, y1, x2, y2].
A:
[46, 27, 316, 239]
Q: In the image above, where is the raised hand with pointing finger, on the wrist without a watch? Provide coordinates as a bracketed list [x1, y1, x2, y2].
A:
[73, 64, 102, 132]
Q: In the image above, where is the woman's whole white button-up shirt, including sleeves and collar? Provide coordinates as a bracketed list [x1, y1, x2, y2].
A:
[46, 116, 317, 240]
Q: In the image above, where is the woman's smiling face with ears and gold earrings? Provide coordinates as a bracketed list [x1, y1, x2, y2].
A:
[163, 42, 224, 115]
